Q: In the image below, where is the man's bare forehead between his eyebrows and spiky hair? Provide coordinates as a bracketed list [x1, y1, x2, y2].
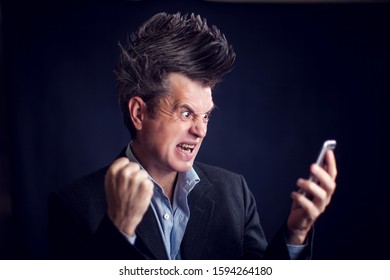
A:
[167, 73, 214, 112]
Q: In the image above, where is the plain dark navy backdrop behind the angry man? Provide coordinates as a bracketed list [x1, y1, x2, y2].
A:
[0, 1, 390, 259]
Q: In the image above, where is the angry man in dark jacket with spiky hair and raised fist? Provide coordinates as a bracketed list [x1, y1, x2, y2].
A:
[49, 13, 337, 259]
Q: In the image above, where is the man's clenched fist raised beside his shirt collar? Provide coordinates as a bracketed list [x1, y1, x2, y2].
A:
[105, 157, 153, 236]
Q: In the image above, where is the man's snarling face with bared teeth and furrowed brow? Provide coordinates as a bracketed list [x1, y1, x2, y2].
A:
[137, 73, 214, 176]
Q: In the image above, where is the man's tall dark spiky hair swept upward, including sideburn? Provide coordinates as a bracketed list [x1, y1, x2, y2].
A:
[116, 13, 236, 137]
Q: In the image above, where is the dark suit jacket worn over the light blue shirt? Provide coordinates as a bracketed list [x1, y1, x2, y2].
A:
[48, 154, 311, 259]
